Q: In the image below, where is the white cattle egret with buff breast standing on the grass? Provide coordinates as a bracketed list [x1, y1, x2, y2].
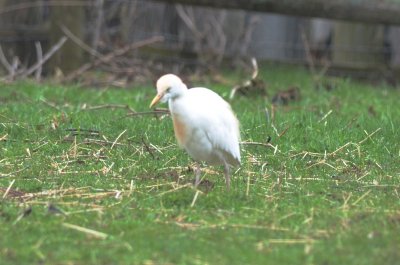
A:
[150, 74, 240, 190]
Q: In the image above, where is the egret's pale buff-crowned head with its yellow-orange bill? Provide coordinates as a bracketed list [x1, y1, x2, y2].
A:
[150, 74, 187, 108]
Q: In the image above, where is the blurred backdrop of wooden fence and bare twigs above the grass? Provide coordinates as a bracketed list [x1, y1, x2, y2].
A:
[0, 0, 400, 87]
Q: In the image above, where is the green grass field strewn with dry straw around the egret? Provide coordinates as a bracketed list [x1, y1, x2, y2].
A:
[0, 65, 400, 265]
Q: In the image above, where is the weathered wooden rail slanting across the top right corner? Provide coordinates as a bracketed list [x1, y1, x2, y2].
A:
[152, 0, 400, 25]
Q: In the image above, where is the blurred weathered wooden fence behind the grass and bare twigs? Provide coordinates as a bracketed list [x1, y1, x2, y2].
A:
[0, 0, 400, 77]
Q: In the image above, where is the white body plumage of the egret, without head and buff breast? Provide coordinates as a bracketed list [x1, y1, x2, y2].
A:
[169, 87, 240, 166]
